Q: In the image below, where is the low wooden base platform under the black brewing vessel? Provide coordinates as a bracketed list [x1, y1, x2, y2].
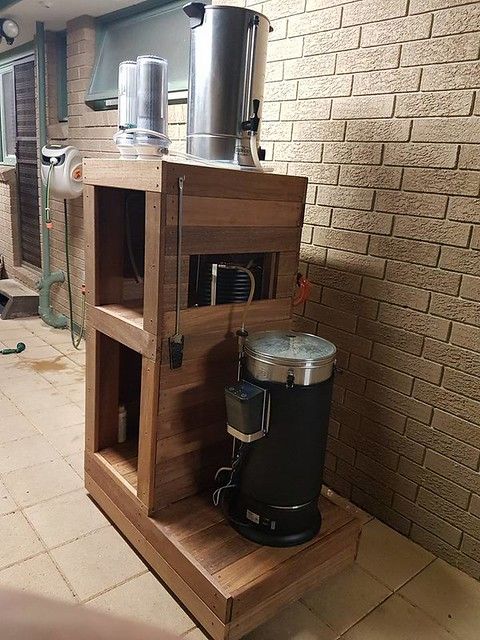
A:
[85, 450, 360, 640]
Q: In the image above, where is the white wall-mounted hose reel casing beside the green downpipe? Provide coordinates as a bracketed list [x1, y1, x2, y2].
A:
[41, 144, 83, 200]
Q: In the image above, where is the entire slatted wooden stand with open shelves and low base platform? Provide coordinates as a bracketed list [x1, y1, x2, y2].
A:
[84, 159, 359, 640]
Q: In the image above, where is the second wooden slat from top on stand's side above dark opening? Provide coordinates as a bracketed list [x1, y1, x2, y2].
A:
[166, 195, 303, 228]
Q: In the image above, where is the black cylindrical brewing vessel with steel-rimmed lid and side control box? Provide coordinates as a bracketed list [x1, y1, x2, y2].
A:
[224, 331, 336, 547]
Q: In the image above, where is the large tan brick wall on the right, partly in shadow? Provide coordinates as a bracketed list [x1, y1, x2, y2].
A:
[231, 0, 480, 577]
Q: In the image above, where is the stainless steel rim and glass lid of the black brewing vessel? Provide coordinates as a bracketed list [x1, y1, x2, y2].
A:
[245, 331, 337, 385]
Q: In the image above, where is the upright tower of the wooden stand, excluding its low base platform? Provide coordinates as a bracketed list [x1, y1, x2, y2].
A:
[85, 159, 306, 528]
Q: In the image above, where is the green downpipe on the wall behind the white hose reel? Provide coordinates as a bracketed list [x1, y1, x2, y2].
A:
[35, 22, 68, 329]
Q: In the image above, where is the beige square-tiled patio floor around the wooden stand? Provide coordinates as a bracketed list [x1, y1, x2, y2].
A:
[0, 319, 480, 640]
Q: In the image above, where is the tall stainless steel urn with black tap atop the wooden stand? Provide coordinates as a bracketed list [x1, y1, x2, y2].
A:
[184, 3, 270, 166]
